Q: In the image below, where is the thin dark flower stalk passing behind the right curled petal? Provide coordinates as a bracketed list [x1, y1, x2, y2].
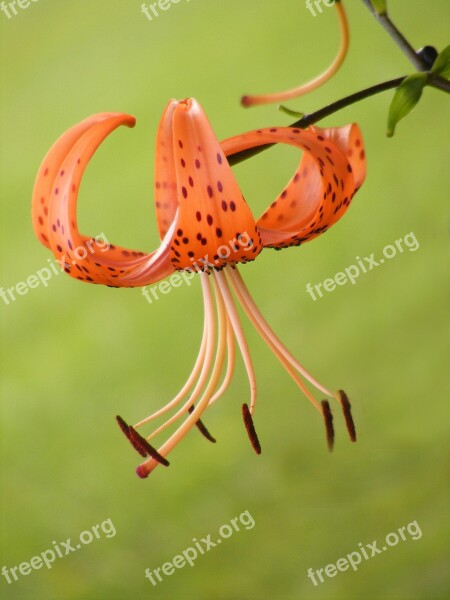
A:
[227, 77, 404, 165]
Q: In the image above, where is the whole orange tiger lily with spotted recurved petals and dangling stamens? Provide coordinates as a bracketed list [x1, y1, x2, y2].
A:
[32, 99, 365, 477]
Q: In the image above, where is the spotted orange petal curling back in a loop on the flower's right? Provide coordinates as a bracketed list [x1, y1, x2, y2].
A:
[222, 125, 365, 248]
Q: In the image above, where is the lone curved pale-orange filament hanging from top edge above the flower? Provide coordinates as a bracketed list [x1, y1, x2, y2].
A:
[241, 2, 349, 106]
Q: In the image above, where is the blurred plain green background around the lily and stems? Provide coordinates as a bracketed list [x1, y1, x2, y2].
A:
[0, 0, 450, 600]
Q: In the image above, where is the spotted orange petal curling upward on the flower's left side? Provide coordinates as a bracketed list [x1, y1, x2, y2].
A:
[32, 113, 174, 287]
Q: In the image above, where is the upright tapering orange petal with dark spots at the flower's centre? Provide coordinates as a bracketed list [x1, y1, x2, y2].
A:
[167, 99, 262, 270]
